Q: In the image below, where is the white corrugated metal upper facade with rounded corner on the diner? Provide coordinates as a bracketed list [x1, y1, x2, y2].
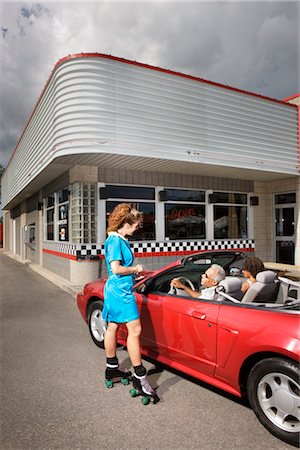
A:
[2, 57, 299, 207]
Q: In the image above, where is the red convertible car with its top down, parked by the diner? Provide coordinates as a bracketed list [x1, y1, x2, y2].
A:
[77, 251, 300, 446]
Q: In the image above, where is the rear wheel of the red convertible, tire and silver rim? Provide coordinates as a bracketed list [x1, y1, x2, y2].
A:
[247, 357, 300, 447]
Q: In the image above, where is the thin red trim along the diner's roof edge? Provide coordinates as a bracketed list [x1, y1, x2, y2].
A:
[4, 53, 297, 172]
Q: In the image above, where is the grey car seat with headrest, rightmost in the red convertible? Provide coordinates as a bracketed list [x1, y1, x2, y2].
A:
[242, 270, 280, 303]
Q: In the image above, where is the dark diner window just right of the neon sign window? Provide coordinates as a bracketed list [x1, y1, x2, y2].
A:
[213, 192, 248, 239]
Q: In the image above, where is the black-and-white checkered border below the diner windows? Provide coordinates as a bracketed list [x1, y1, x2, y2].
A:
[43, 239, 255, 260]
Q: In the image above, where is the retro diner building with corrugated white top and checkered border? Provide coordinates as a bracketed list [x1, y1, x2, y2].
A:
[2, 53, 300, 284]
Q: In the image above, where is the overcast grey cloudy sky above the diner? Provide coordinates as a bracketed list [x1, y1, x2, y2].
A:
[0, 1, 300, 165]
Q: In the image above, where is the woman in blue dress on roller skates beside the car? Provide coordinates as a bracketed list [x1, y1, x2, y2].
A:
[102, 203, 159, 403]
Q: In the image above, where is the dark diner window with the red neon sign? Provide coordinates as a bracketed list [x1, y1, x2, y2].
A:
[163, 189, 206, 240]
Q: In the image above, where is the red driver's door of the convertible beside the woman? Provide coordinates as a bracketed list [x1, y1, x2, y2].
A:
[136, 292, 220, 374]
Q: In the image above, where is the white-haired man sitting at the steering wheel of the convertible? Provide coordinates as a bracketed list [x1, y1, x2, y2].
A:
[171, 264, 225, 300]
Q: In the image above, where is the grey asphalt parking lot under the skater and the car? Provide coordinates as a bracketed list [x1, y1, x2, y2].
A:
[0, 252, 293, 450]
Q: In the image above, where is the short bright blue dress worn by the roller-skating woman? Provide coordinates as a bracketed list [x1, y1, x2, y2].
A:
[102, 232, 140, 323]
